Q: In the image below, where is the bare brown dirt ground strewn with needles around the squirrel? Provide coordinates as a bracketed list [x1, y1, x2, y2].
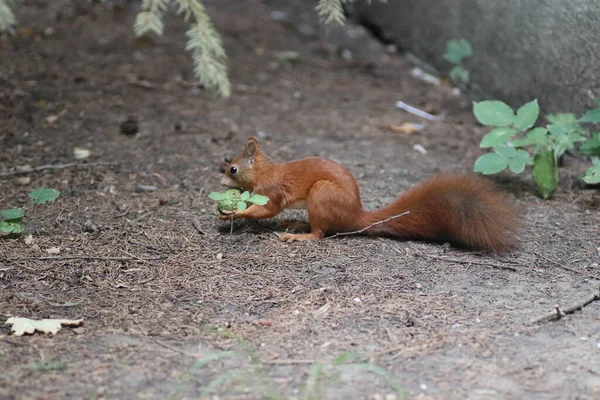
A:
[0, 0, 600, 399]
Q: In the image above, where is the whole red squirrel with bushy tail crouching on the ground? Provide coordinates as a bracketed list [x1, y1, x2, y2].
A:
[220, 137, 517, 253]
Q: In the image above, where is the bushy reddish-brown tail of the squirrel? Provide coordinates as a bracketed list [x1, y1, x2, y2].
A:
[359, 173, 517, 253]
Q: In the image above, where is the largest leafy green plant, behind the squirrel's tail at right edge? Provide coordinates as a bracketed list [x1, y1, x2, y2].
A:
[473, 100, 600, 199]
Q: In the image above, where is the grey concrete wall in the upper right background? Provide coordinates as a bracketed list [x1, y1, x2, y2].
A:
[349, 0, 600, 113]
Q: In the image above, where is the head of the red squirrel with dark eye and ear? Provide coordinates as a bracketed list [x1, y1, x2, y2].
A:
[221, 137, 262, 191]
